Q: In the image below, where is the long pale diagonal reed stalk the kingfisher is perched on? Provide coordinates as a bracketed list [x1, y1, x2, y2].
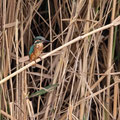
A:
[0, 16, 120, 84]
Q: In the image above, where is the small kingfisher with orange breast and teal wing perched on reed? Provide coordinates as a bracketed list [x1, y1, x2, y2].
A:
[29, 36, 49, 61]
